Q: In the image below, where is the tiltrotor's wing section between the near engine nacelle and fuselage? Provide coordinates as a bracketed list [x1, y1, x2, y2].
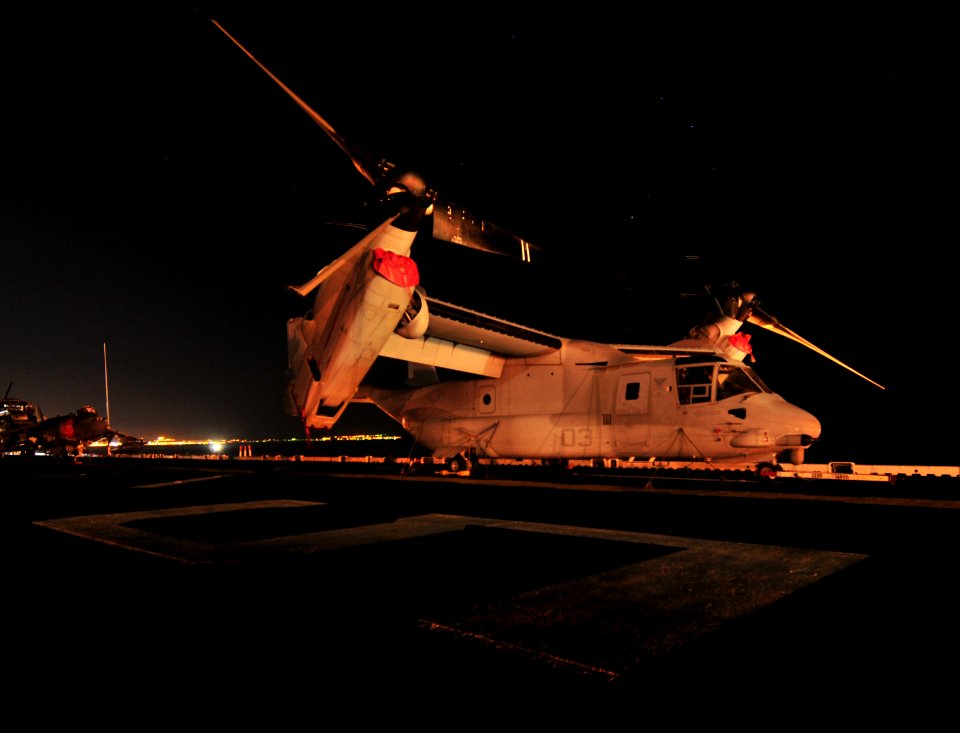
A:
[380, 296, 563, 377]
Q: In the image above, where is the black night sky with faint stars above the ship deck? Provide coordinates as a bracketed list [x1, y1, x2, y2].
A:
[0, 4, 960, 465]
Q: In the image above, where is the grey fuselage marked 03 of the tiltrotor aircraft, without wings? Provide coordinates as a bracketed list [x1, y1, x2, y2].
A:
[371, 341, 820, 463]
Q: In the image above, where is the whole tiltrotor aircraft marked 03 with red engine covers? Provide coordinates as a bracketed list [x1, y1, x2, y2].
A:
[213, 21, 882, 472]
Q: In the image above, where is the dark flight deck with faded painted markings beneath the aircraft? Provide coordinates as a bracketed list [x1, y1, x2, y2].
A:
[9, 458, 960, 716]
